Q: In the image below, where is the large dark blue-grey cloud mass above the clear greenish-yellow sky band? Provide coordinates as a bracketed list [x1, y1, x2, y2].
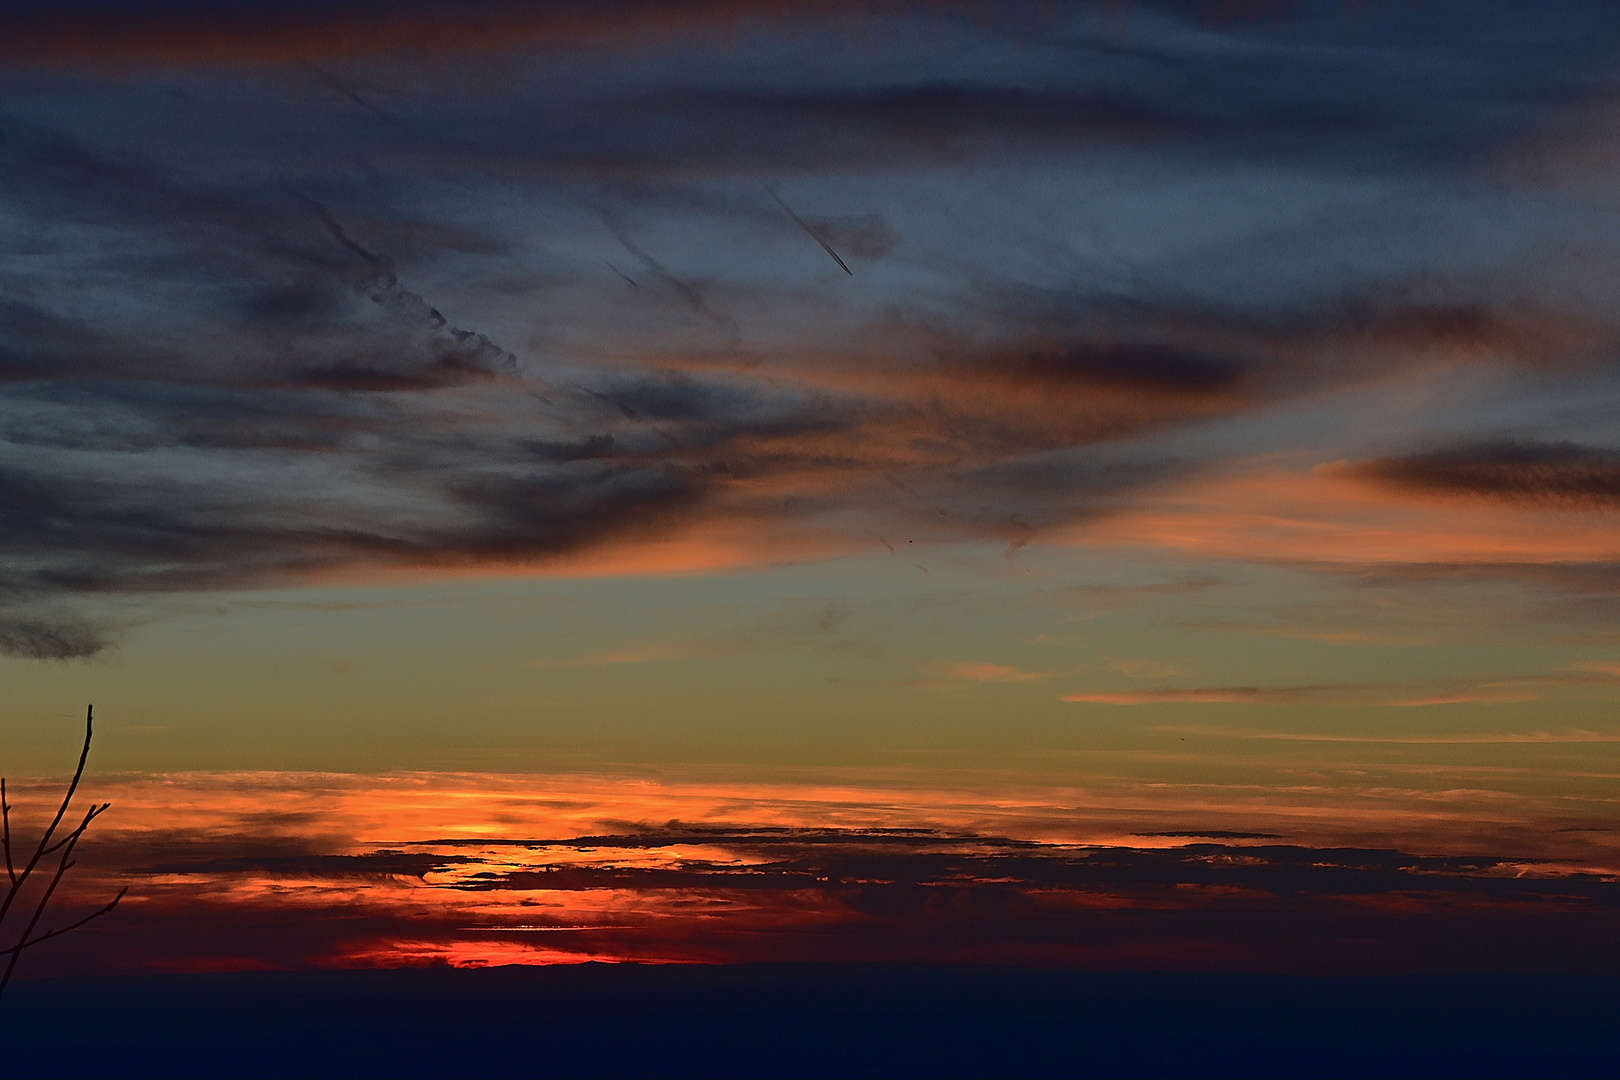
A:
[0, 3, 1620, 657]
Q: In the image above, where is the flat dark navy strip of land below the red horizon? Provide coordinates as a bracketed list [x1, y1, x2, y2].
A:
[0, 963, 1620, 1077]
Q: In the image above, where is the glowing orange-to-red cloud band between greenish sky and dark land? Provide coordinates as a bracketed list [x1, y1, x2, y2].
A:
[16, 767, 1620, 972]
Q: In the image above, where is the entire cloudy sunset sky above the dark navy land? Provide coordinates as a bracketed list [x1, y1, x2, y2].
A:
[0, 0, 1620, 972]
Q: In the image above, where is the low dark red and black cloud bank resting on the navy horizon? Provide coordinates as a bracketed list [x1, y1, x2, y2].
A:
[36, 792, 1620, 975]
